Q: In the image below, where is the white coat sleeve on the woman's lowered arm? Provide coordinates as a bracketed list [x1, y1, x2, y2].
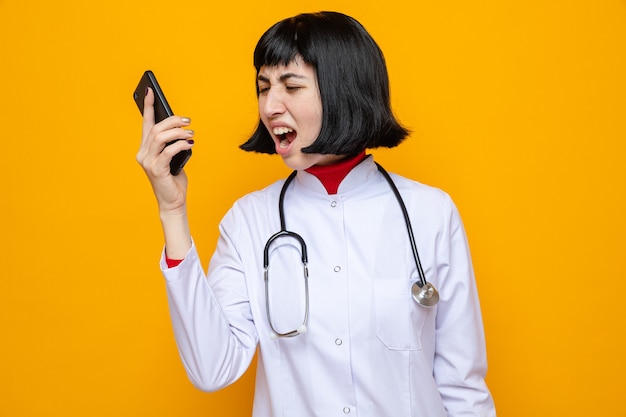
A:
[433, 197, 496, 417]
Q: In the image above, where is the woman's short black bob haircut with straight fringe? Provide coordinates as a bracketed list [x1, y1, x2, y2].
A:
[236, 12, 409, 155]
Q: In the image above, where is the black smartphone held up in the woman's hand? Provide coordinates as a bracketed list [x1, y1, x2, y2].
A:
[133, 70, 191, 175]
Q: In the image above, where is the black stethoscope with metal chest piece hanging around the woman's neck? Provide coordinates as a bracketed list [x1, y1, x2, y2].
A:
[263, 163, 439, 338]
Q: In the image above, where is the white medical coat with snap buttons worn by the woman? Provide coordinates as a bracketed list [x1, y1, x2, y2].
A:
[161, 157, 495, 417]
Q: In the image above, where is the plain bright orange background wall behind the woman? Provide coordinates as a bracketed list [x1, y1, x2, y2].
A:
[0, 0, 626, 417]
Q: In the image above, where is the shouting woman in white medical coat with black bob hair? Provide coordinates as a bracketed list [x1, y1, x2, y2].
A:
[137, 12, 495, 417]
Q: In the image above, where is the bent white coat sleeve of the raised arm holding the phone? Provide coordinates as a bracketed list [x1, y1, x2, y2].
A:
[161, 206, 258, 391]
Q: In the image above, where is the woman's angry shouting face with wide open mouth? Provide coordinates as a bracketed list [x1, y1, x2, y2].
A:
[257, 58, 341, 170]
